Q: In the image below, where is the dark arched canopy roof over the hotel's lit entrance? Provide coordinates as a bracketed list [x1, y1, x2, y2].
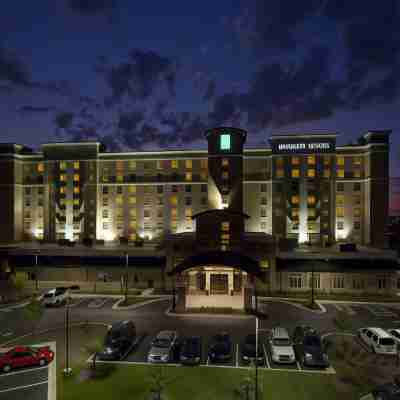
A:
[168, 251, 265, 281]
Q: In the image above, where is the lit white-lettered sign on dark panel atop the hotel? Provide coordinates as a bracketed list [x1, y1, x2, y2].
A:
[271, 139, 335, 153]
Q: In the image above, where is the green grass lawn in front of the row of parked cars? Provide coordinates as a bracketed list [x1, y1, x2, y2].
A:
[57, 365, 346, 400]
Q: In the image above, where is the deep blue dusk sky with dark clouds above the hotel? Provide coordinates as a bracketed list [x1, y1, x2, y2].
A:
[0, 0, 400, 209]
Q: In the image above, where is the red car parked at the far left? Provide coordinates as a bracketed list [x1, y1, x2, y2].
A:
[0, 346, 54, 372]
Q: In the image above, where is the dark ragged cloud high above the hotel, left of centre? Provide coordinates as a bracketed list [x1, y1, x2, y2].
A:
[96, 49, 177, 107]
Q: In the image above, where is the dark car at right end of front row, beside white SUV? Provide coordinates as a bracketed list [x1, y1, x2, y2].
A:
[293, 326, 329, 368]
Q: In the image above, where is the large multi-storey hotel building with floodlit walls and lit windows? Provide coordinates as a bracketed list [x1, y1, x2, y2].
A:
[0, 127, 397, 310]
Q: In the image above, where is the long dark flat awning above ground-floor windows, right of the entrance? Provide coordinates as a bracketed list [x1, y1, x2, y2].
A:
[276, 258, 400, 272]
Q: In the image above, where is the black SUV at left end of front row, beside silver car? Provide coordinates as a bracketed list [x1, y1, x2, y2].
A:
[97, 319, 136, 360]
